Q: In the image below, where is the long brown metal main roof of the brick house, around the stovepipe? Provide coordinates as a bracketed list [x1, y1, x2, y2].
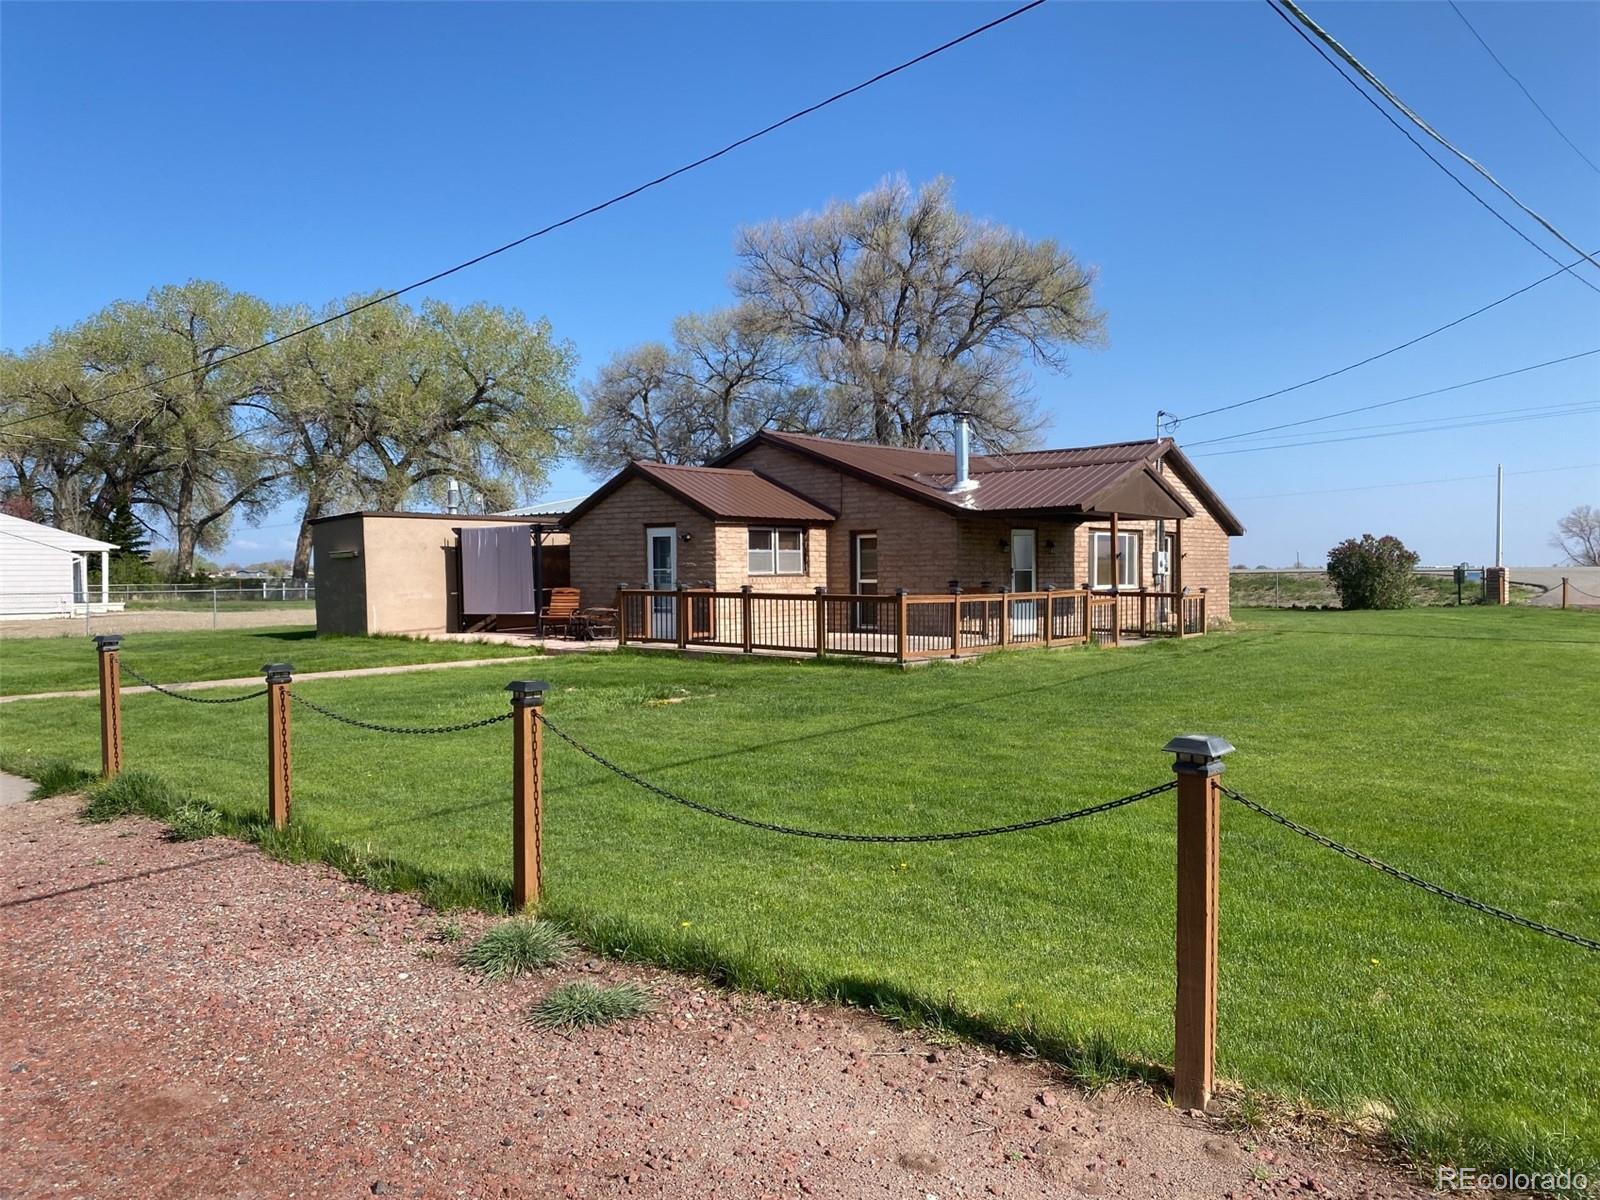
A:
[718, 429, 1245, 534]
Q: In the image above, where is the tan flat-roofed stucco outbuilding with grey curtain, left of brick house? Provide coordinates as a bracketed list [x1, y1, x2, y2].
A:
[310, 512, 569, 634]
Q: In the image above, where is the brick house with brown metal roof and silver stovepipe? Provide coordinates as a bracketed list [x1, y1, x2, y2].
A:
[563, 421, 1243, 640]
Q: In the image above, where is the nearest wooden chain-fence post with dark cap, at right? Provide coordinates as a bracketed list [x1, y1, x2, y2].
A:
[1162, 733, 1234, 1112]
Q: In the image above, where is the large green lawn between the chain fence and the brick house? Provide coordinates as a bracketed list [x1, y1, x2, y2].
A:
[0, 608, 1600, 1176]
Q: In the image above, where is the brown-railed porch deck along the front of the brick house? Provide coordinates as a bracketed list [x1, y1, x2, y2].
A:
[618, 587, 1206, 664]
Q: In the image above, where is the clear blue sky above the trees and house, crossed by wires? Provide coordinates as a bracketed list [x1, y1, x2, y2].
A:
[0, 0, 1600, 565]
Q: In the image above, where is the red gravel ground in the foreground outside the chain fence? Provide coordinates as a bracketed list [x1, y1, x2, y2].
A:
[0, 798, 1429, 1200]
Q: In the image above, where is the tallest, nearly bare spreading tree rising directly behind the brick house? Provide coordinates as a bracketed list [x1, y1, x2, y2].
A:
[734, 179, 1104, 450]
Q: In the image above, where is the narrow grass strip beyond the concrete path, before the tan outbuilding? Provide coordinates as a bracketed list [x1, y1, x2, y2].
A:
[0, 626, 528, 707]
